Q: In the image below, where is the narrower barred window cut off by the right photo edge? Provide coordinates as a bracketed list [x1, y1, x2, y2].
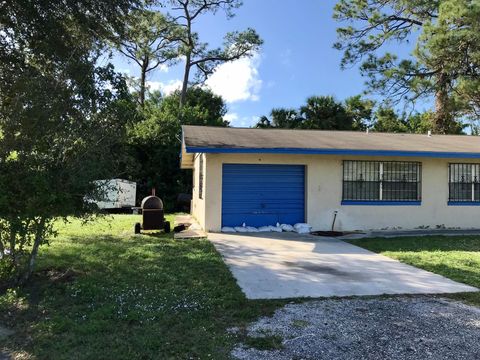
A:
[448, 164, 480, 202]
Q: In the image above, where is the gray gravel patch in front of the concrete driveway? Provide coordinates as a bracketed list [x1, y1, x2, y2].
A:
[232, 297, 480, 360]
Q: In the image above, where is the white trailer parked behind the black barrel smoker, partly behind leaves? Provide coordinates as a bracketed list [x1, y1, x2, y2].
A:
[95, 179, 137, 210]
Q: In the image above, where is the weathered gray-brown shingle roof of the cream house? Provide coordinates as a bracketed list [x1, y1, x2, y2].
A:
[183, 126, 480, 157]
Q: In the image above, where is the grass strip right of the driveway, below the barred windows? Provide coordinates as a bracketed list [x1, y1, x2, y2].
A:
[349, 236, 480, 306]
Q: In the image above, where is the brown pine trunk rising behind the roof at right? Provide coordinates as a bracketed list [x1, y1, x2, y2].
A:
[433, 73, 453, 134]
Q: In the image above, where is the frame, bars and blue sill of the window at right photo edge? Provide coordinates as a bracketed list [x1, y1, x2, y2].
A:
[448, 163, 480, 206]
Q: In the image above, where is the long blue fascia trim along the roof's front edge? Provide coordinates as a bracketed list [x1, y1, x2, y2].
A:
[186, 146, 480, 159]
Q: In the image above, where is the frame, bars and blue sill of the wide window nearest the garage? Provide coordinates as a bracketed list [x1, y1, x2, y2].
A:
[341, 160, 422, 205]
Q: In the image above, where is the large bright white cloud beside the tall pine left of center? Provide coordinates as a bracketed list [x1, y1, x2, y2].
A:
[206, 55, 262, 103]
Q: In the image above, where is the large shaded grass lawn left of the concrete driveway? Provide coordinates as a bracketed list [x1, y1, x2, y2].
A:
[0, 215, 285, 359]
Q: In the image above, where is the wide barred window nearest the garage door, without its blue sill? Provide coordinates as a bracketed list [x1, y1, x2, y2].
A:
[342, 160, 422, 202]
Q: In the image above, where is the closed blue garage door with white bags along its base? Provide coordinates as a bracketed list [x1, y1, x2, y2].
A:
[222, 164, 305, 227]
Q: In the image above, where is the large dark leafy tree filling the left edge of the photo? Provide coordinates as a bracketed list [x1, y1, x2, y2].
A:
[0, 0, 141, 285]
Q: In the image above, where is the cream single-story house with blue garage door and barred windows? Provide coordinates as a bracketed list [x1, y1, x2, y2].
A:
[181, 126, 480, 231]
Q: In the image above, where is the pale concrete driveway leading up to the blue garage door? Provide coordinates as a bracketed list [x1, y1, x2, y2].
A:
[208, 233, 478, 299]
